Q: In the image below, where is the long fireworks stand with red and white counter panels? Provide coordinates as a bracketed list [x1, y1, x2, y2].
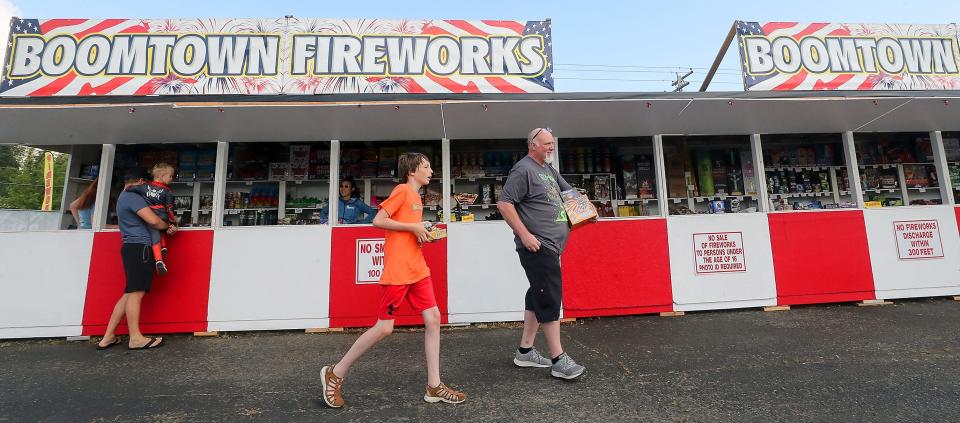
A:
[0, 19, 960, 338]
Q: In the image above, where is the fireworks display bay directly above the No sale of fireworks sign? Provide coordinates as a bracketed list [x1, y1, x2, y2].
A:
[663, 136, 761, 215]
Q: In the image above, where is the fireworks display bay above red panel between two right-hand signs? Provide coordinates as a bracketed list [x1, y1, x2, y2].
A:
[761, 134, 857, 211]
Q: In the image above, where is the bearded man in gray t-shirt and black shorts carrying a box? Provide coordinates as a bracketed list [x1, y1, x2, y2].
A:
[497, 128, 586, 379]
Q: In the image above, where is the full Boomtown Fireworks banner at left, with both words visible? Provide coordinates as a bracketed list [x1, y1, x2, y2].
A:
[0, 18, 553, 97]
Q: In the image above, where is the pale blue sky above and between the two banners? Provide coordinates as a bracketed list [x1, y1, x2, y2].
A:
[0, 0, 960, 92]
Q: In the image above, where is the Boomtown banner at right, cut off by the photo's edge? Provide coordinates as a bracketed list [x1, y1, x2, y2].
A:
[736, 21, 960, 91]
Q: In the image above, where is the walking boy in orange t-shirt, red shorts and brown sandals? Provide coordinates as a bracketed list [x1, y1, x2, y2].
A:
[320, 153, 467, 408]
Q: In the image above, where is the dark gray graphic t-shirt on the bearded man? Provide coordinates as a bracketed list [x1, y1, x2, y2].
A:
[498, 156, 571, 254]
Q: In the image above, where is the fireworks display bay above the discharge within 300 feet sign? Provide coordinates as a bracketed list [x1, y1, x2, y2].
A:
[854, 133, 954, 208]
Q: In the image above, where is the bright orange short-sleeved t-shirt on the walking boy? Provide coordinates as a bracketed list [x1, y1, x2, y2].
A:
[380, 184, 430, 285]
